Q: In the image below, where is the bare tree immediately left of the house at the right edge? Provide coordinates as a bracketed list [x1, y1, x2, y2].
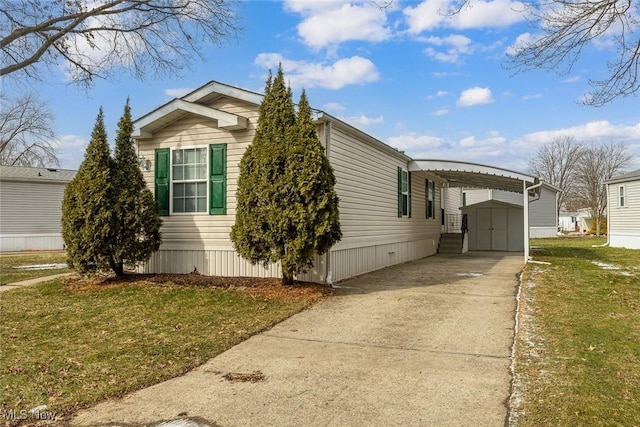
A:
[578, 143, 632, 236]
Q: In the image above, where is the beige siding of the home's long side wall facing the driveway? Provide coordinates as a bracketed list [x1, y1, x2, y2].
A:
[329, 126, 441, 281]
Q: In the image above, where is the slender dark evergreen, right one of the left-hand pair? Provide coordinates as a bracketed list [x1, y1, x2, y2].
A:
[108, 99, 162, 276]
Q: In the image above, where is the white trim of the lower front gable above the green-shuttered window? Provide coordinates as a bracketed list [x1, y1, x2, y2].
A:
[132, 99, 248, 139]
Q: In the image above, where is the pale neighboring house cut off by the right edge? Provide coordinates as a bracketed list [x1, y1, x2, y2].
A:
[606, 169, 640, 249]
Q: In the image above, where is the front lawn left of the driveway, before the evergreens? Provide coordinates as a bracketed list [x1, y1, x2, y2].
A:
[0, 279, 321, 422]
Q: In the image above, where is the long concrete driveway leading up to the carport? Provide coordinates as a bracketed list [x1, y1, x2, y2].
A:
[73, 252, 523, 426]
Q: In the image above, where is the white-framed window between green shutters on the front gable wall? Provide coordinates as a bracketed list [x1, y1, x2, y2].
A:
[171, 147, 207, 213]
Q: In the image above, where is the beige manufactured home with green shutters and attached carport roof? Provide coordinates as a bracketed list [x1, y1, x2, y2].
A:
[133, 82, 552, 283]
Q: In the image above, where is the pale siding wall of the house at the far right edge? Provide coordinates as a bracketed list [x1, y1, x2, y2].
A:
[608, 180, 640, 249]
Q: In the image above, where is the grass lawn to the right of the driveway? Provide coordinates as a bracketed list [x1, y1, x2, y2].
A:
[516, 237, 640, 426]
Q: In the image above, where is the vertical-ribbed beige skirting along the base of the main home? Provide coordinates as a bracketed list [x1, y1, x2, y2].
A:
[141, 239, 437, 283]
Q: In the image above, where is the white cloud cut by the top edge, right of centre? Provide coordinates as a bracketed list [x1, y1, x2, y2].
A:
[403, 0, 525, 34]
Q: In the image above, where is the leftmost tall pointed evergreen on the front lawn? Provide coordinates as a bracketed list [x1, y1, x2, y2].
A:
[62, 108, 114, 273]
